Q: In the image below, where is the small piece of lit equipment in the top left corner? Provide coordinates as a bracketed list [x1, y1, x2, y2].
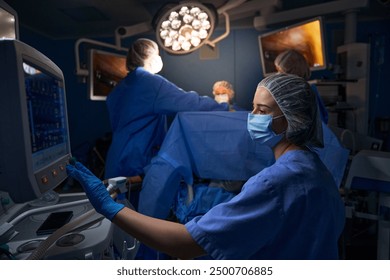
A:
[0, 0, 19, 40]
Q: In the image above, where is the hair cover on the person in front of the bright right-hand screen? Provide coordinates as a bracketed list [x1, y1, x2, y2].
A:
[274, 49, 311, 80]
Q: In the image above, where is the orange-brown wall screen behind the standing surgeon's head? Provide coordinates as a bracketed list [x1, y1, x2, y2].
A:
[88, 49, 127, 100]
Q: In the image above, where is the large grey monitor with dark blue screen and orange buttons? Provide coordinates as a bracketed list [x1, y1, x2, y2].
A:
[0, 40, 71, 203]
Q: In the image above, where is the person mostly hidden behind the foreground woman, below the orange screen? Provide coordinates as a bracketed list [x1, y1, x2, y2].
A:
[274, 49, 328, 124]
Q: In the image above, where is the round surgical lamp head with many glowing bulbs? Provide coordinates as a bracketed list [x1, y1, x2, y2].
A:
[155, 2, 216, 54]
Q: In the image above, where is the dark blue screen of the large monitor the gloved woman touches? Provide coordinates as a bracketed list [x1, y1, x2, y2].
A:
[23, 62, 69, 171]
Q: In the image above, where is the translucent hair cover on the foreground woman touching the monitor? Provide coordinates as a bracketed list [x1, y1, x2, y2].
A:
[258, 73, 323, 147]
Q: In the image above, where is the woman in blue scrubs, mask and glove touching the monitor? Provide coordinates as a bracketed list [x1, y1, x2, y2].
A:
[67, 74, 345, 259]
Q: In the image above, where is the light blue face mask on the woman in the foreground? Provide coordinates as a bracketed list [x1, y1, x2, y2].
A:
[247, 113, 283, 148]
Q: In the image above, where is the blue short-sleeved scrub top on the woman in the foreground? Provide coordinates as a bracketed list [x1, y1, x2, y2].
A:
[185, 150, 345, 259]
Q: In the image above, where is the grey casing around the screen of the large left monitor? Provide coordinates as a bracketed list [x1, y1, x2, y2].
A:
[0, 40, 71, 203]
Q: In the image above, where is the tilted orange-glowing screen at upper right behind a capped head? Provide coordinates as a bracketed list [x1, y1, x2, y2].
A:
[258, 17, 327, 76]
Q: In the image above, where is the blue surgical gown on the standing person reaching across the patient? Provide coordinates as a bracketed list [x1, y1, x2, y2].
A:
[105, 67, 228, 178]
